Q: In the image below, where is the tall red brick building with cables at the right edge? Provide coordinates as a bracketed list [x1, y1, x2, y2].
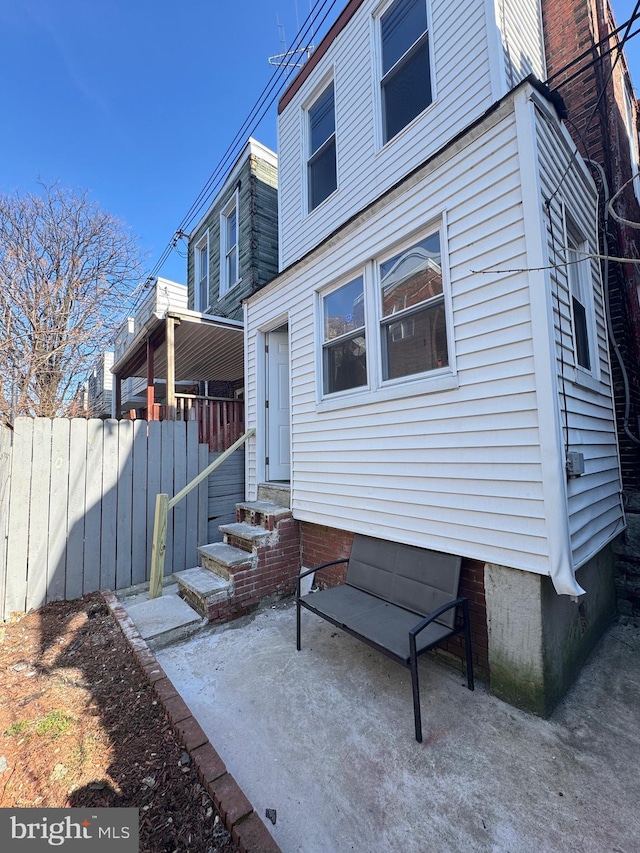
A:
[542, 0, 640, 493]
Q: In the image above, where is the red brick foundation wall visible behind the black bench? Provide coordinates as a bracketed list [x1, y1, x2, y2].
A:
[300, 522, 489, 680]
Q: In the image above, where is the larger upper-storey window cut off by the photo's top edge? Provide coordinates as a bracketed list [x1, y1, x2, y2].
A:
[380, 0, 432, 143]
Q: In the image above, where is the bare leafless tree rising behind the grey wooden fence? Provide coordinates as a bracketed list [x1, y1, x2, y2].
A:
[0, 184, 140, 417]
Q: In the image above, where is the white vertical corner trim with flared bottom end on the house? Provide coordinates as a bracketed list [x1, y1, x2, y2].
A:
[514, 86, 585, 596]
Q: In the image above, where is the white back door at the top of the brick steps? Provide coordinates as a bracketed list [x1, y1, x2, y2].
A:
[266, 331, 291, 481]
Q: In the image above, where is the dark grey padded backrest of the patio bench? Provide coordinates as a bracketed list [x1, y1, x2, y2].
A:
[346, 534, 462, 628]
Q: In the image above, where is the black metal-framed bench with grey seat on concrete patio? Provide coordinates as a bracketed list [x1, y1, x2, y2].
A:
[296, 534, 473, 742]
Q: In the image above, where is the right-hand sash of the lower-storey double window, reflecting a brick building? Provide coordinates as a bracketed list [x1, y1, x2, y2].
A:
[379, 234, 449, 380]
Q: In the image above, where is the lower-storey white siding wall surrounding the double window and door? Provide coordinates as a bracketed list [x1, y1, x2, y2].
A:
[247, 100, 548, 573]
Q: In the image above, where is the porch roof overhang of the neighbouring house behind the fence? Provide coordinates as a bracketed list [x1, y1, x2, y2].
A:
[111, 310, 244, 382]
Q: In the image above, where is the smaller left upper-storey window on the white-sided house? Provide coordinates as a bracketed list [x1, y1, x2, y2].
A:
[307, 83, 338, 211]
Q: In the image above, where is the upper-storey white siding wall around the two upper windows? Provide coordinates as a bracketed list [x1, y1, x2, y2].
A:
[279, 0, 543, 269]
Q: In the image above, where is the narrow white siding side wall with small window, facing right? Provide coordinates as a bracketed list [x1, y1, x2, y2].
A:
[537, 103, 624, 566]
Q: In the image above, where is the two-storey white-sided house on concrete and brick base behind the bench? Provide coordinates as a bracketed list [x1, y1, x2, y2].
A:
[245, 0, 625, 714]
